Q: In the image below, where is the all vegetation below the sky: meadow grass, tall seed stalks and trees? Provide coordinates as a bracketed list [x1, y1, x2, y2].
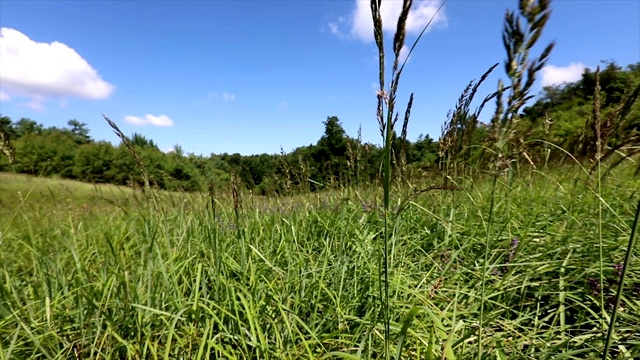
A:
[0, 0, 640, 360]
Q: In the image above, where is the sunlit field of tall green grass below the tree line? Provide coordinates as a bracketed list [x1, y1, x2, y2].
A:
[0, 168, 640, 359]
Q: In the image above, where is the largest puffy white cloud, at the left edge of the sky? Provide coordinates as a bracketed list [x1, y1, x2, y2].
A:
[0, 28, 114, 104]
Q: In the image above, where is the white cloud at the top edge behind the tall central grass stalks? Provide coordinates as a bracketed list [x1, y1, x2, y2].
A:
[338, 0, 447, 42]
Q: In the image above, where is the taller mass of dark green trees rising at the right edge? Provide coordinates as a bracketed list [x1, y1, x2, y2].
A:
[523, 61, 640, 167]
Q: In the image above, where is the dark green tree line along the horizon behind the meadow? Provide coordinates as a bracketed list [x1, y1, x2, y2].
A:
[0, 61, 640, 195]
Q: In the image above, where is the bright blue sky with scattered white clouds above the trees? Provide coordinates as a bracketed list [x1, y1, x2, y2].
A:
[0, 0, 640, 155]
